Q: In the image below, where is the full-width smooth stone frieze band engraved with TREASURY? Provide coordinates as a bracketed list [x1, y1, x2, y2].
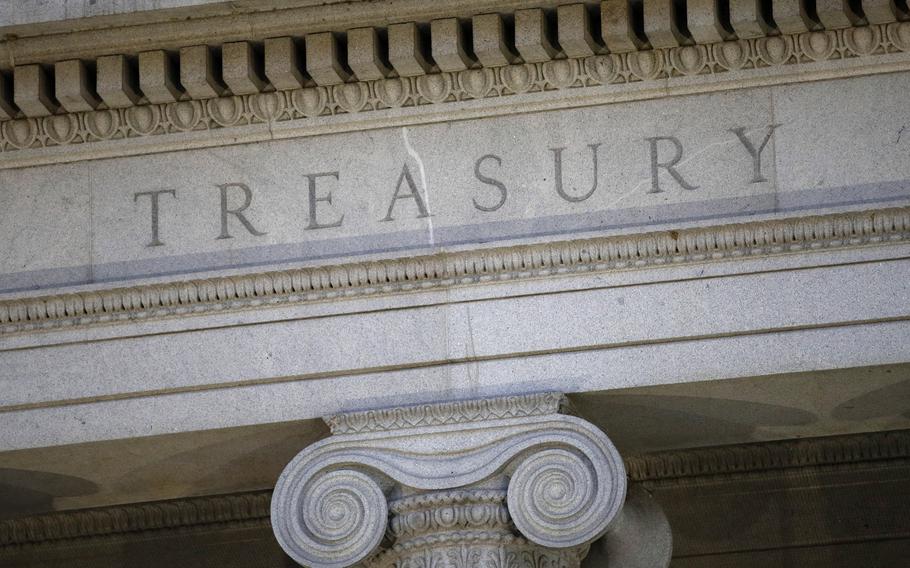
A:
[0, 80, 910, 292]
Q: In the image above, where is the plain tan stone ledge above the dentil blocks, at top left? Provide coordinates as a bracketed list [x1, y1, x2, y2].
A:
[0, 0, 548, 62]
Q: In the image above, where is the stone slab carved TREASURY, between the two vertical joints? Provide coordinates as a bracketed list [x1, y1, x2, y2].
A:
[7, 90, 780, 288]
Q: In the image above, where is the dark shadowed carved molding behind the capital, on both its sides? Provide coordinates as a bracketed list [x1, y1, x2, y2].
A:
[0, 430, 910, 553]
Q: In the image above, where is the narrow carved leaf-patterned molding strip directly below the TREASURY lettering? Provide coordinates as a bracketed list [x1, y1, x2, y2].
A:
[0, 207, 910, 335]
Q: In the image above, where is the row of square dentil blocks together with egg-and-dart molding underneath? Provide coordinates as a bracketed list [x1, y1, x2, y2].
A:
[0, 0, 910, 169]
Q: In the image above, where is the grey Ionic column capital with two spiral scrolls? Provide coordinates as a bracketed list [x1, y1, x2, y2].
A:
[272, 393, 626, 568]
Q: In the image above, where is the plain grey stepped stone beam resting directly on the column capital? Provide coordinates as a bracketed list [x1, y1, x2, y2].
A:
[0, 252, 910, 449]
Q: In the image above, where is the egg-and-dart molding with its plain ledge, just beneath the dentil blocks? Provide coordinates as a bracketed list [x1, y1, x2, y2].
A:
[0, 18, 910, 169]
